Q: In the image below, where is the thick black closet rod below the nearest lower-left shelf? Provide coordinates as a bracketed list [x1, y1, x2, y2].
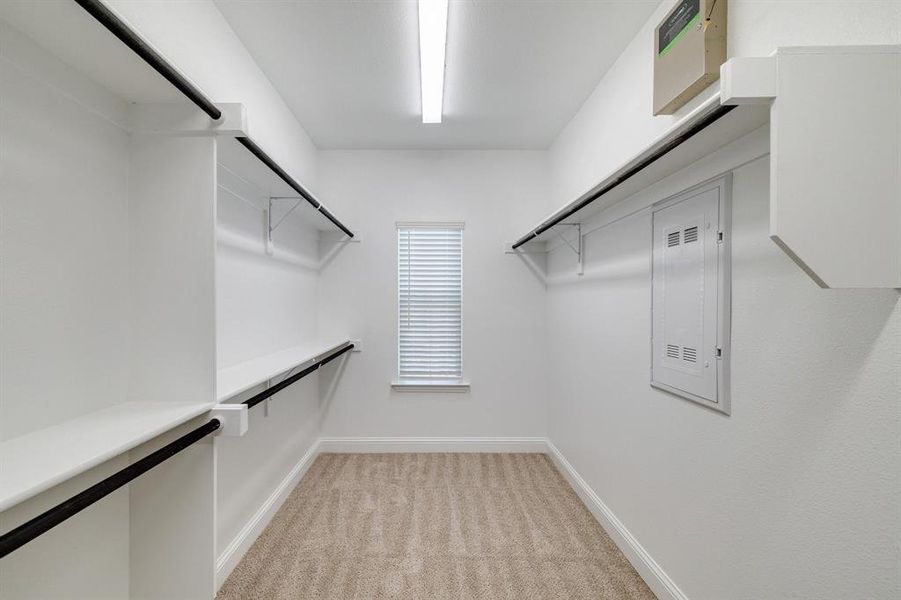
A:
[0, 419, 220, 558]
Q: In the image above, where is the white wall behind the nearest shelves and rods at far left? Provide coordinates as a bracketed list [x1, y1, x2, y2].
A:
[0, 27, 131, 598]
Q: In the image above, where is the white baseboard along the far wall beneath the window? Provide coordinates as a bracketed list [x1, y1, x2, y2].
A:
[319, 437, 547, 454]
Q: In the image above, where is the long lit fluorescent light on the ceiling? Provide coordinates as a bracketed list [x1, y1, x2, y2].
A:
[419, 0, 447, 123]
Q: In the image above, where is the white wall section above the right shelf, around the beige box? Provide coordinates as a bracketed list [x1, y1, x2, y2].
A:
[548, 0, 901, 209]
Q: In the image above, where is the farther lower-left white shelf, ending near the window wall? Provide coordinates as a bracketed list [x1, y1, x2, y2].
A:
[216, 339, 350, 402]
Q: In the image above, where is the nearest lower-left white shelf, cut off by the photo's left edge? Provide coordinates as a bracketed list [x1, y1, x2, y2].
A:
[0, 402, 213, 511]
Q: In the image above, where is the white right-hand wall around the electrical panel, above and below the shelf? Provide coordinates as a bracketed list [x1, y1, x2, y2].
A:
[536, 0, 901, 600]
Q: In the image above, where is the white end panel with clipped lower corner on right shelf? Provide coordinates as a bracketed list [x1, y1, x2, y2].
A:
[723, 45, 901, 288]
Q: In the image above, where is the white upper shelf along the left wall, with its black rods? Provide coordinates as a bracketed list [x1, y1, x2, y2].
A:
[0, 0, 354, 238]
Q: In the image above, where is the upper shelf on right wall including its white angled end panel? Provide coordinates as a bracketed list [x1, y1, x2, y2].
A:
[513, 45, 901, 288]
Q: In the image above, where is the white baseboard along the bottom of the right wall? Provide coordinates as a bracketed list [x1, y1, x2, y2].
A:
[547, 440, 688, 600]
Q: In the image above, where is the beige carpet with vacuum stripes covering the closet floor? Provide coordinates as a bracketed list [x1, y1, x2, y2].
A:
[217, 454, 654, 600]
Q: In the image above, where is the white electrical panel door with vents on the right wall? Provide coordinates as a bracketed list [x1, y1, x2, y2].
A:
[651, 177, 731, 413]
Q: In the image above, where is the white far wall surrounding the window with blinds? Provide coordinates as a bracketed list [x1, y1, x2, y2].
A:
[320, 151, 547, 437]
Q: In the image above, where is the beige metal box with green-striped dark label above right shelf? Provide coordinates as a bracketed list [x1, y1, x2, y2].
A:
[654, 0, 727, 115]
